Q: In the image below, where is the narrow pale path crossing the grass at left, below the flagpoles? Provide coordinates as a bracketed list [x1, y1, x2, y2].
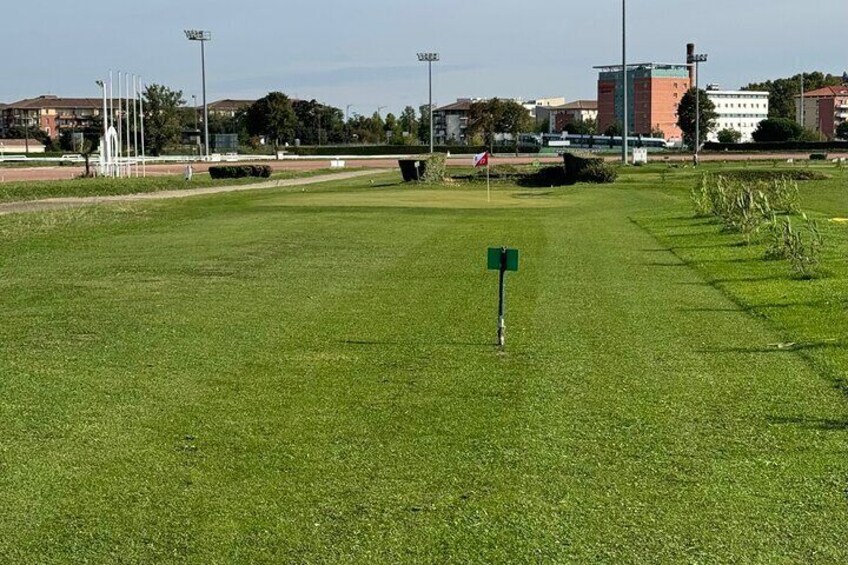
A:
[0, 169, 388, 216]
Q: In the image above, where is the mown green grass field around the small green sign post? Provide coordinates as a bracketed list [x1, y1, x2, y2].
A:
[0, 166, 848, 563]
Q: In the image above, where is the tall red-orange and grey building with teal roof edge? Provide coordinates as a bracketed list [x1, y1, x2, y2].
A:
[596, 63, 694, 141]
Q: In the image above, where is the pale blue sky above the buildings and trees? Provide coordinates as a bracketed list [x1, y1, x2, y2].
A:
[0, 0, 848, 114]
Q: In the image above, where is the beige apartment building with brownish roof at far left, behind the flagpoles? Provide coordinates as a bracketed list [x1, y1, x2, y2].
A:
[2, 95, 103, 139]
